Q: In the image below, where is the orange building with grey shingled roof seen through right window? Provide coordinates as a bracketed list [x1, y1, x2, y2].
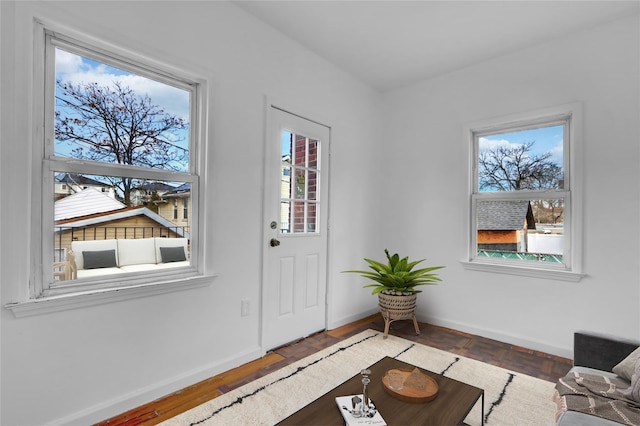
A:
[476, 200, 536, 252]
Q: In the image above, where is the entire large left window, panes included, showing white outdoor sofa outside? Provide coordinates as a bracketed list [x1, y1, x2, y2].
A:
[32, 29, 202, 298]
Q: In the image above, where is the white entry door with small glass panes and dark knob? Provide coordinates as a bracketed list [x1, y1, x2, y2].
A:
[262, 107, 329, 350]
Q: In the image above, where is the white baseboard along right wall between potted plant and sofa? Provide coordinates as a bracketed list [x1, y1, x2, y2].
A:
[417, 315, 573, 359]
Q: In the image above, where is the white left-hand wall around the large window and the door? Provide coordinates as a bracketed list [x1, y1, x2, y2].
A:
[0, 1, 381, 425]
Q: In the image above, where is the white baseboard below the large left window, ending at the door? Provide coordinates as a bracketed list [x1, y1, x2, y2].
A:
[49, 348, 261, 425]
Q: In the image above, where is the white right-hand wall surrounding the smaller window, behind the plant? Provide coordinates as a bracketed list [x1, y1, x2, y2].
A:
[383, 16, 640, 357]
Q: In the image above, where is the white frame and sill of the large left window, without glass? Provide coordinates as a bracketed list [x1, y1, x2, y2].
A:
[7, 21, 215, 316]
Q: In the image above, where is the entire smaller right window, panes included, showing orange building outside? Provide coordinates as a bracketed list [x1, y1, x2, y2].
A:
[467, 105, 580, 280]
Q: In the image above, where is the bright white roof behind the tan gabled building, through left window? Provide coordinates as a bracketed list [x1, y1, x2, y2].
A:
[54, 188, 127, 222]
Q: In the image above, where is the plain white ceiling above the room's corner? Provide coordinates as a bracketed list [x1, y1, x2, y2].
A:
[234, 0, 640, 91]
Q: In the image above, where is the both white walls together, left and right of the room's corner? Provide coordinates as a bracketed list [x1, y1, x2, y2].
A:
[0, 1, 640, 424]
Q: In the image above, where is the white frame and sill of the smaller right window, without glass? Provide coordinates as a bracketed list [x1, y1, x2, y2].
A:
[462, 102, 584, 282]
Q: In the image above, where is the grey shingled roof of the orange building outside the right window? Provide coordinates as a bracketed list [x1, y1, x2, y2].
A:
[476, 200, 536, 231]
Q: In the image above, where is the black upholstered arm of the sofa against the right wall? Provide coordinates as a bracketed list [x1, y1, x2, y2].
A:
[573, 332, 640, 371]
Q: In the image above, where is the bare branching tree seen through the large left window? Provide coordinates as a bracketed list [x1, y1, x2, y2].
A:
[55, 80, 189, 204]
